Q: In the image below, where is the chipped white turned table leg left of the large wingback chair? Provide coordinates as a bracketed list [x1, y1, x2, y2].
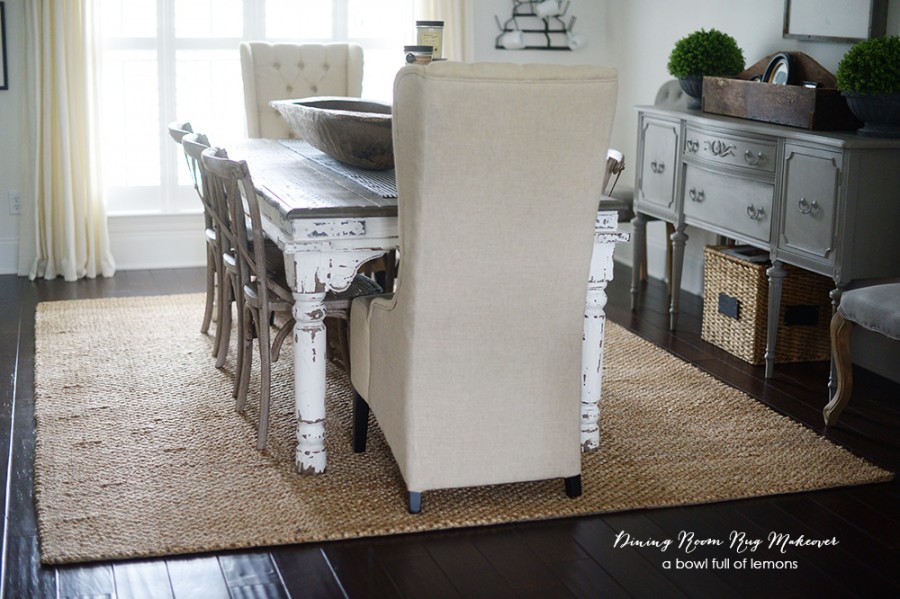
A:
[293, 292, 327, 474]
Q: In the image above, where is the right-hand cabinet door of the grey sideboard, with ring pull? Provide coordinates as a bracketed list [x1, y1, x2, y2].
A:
[779, 143, 841, 267]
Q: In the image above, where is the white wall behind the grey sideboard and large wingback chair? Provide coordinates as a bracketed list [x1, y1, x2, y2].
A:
[473, 0, 900, 294]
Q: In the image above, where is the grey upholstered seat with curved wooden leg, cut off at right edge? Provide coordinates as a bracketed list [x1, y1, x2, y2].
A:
[822, 283, 900, 426]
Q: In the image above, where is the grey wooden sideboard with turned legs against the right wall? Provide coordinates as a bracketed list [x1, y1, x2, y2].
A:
[631, 106, 900, 377]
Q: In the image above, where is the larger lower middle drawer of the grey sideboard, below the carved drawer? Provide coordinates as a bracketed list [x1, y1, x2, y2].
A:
[684, 164, 775, 243]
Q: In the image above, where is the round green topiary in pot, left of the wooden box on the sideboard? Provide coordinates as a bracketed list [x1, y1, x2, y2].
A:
[668, 29, 744, 108]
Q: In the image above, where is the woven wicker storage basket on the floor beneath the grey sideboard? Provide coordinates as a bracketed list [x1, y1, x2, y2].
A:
[700, 246, 834, 364]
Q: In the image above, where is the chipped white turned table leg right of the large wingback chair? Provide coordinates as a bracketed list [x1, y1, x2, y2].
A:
[581, 212, 628, 451]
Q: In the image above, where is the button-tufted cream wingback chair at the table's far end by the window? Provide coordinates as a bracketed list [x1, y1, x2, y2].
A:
[240, 42, 363, 139]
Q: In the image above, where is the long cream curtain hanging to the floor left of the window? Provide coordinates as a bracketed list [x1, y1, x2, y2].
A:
[20, 0, 115, 281]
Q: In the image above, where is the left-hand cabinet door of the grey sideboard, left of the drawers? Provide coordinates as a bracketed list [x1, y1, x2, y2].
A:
[638, 115, 681, 218]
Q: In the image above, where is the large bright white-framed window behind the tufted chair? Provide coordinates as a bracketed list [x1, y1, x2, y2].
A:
[99, 0, 414, 214]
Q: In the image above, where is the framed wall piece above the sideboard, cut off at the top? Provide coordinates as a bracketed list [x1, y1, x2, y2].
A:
[783, 0, 888, 43]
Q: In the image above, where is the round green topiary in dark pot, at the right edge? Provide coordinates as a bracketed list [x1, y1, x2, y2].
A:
[836, 35, 900, 137]
